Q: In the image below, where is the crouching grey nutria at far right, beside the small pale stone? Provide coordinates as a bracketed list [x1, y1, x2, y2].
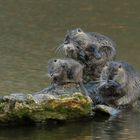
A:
[99, 61, 140, 107]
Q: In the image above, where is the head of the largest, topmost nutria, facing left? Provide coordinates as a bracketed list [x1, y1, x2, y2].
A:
[63, 28, 91, 59]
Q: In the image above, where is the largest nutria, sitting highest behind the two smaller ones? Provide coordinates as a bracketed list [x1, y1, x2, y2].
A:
[62, 28, 116, 81]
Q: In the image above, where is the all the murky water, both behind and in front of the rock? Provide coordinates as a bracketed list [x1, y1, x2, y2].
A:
[0, 0, 140, 140]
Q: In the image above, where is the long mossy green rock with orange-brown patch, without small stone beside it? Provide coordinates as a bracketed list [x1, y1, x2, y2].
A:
[0, 88, 92, 124]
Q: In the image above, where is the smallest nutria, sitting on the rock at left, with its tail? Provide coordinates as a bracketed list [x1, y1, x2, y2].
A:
[48, 58, 88, 96]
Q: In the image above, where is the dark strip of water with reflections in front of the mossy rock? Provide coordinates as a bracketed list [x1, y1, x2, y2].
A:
[0, 113, 140, 140]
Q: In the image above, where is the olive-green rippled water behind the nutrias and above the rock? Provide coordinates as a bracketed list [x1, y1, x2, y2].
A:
[0, 0, 140, 94]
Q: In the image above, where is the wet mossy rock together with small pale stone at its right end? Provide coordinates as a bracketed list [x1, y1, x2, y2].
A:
[0, 83, 133, 125]
